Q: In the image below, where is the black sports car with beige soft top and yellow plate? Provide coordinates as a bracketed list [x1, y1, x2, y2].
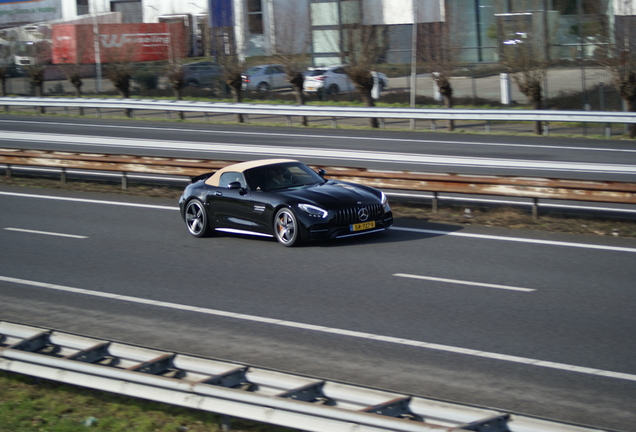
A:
[179, 159, 393, 246]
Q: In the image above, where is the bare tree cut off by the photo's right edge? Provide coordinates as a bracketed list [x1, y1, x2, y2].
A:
[601, 1, 636, 138]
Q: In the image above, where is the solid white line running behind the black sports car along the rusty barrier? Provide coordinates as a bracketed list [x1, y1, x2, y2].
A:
[0, 191, 636, 253]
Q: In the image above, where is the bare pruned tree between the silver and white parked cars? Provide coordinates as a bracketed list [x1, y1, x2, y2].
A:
[272, 8, 311, 126]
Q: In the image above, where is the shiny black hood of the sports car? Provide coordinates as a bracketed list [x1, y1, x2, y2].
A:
[281, 180, 381, 210]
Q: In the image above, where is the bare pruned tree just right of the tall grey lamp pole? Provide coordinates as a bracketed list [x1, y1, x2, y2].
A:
[417, 7, 464, 131]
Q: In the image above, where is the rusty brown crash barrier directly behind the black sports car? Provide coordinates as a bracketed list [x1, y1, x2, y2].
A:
[0, 148, 636, 218]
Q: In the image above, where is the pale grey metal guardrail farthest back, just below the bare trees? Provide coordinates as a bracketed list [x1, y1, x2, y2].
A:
[0, 97, 636, 136]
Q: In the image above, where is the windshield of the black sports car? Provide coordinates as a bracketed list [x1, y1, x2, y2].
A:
[244, 162, 324, 191]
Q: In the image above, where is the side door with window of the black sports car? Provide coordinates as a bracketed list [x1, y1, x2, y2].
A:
[208, 171, 254, 231]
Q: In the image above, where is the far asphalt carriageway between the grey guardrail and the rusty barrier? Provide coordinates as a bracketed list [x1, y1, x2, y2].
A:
[0, 115, 636, 181]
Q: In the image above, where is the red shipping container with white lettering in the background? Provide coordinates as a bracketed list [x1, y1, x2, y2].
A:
[51, 23, 188, 64]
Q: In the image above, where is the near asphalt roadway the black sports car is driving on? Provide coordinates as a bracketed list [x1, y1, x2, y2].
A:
[0, 186, 636, 431]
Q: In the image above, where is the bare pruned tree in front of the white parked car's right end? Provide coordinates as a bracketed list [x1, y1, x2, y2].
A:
[340, 24, 387, 128]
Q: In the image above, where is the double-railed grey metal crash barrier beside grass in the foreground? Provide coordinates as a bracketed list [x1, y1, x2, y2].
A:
[0, 321, 600, 432]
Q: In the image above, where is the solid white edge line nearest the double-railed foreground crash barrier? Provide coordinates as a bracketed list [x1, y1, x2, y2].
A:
[0, 276, 636, 381]
